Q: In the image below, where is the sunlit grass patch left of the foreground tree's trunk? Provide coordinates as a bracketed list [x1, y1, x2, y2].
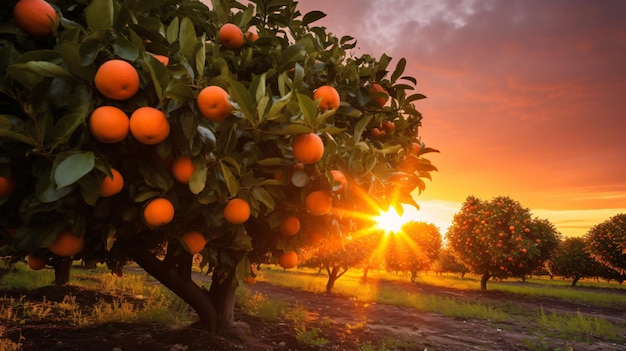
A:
[0, 264, 190, 328]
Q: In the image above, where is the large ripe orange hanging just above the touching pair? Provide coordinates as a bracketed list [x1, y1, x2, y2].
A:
[94, 59, 139, 100]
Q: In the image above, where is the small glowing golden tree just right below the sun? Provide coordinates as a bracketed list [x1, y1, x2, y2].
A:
[385, 222, 441, 282]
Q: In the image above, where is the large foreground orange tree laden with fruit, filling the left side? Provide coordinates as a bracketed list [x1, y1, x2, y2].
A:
[0, 0, 436, 331]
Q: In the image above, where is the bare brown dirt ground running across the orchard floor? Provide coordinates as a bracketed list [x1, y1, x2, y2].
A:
[0, 270, 626, 351]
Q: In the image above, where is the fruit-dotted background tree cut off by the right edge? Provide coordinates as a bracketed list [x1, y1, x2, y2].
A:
[585, 214, 626, 274]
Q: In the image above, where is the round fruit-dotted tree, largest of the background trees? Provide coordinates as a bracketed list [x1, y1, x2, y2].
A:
[446, 196, 560, 290]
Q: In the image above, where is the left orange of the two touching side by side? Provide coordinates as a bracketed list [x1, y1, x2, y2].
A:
[89, 106, 130, 143]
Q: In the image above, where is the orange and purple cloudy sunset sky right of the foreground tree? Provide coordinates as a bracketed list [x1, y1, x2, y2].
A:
[299, 0, 626, 235]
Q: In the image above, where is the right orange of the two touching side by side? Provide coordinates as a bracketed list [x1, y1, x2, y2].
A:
[130, 106, 170, 145]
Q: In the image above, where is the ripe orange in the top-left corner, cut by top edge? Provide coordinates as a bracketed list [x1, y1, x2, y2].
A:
[13, 0, 59, 38]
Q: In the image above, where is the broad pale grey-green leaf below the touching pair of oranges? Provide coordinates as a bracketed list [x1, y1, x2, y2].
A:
[52, 151, 96, 189]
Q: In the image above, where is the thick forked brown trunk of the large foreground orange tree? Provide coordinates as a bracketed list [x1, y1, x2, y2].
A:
[129, 241, 243, 334]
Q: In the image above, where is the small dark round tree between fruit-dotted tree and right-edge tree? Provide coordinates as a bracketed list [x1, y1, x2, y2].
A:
[548, 237, 600, 286]
